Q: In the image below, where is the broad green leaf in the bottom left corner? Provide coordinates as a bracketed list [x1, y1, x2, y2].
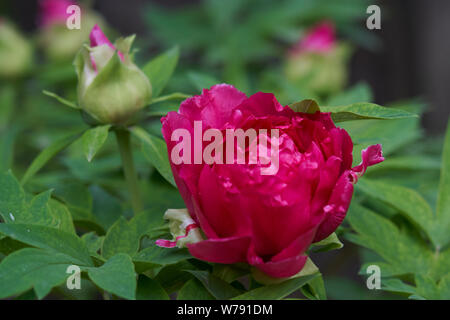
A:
[0, 248, 73, 299]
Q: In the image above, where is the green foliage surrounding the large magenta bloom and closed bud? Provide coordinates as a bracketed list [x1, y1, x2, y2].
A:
[0, 0, 450, 300]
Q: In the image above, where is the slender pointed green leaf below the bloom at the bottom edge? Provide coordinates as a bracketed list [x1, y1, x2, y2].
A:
[233, 274, 319, 300]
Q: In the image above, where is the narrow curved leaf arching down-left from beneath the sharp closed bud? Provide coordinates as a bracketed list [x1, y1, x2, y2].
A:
[20, 130, 84, 185]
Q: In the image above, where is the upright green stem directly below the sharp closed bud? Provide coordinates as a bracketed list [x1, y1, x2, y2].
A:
[115, 129, 142, 215]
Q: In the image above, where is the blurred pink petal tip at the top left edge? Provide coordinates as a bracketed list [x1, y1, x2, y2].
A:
[39, 0, 76, 27]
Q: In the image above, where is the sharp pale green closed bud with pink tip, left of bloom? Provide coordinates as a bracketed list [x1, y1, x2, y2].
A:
[74, 25, 152, 124]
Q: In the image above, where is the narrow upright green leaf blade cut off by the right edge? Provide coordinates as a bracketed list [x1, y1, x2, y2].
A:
[436, 121, 450, 247]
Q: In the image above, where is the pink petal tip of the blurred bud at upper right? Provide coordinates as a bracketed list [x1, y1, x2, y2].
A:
[292, 21, 336, 53]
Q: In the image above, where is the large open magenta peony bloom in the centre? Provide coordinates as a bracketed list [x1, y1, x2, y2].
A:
[162, 84, 384, 277]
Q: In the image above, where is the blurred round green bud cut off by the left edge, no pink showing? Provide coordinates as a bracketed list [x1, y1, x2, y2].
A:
[0, 19, 33, 78]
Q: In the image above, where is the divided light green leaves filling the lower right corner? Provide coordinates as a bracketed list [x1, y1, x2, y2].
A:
[347, 124, 450, 299]
